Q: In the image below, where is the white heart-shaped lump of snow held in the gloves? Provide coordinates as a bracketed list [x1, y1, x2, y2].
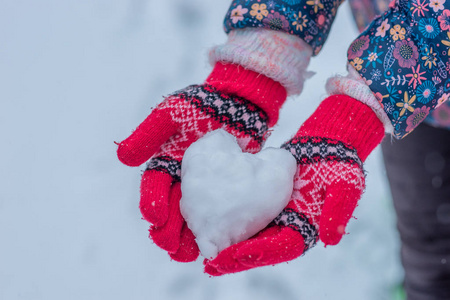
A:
[180, 130, 297, 258]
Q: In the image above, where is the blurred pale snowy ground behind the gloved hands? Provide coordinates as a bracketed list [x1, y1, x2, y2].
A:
[0, 0, 402, 300]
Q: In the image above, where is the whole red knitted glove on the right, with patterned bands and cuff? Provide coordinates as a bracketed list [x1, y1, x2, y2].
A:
[205, 95, 384, 276]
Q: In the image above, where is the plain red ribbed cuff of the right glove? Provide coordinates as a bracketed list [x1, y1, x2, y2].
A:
[296, 95, 384, 162]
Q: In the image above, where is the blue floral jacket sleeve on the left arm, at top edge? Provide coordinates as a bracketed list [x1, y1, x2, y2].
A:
[224, 0, 343, 55]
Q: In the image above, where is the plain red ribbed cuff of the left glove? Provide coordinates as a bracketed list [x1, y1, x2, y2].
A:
[206, 62, 287, 127]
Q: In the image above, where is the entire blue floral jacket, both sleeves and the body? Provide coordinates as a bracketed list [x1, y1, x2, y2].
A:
[224, 0, 450, 138]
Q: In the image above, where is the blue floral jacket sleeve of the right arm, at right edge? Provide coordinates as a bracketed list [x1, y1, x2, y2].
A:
[348, 0, 450, 138]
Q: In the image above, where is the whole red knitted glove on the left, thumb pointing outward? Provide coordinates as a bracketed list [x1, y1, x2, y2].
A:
[117, 63, 286, 262]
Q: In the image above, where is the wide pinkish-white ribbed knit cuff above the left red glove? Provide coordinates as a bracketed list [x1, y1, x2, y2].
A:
[209, 28, 313, 95]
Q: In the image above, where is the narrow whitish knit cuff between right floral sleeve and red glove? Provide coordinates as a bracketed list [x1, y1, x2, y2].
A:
[325, 65, 394, 133]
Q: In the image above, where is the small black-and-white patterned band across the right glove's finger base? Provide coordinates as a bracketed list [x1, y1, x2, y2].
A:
[273, 208, 319, 253]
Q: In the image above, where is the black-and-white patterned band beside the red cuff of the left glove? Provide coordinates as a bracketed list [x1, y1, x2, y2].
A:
[171, 84, 269, 143]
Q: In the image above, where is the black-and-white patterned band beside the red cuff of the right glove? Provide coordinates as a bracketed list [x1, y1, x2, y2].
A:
[281, 136, 363, 169]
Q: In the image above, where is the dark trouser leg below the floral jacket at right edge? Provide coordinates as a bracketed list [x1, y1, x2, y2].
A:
[382, 124, 450, 300]
